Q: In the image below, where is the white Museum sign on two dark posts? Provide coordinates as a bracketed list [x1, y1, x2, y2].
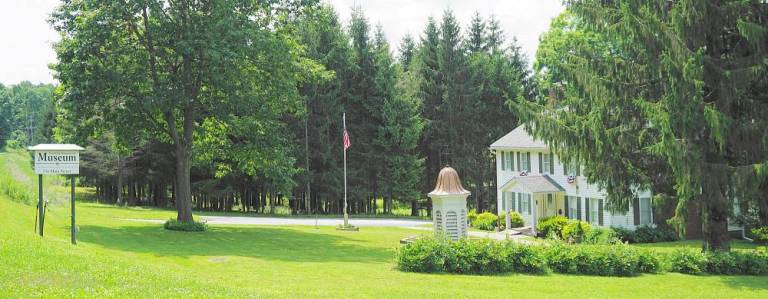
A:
[28, 144, 84, 244]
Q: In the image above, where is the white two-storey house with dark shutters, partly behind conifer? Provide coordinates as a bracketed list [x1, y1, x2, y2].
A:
[490, 126, 653, 229]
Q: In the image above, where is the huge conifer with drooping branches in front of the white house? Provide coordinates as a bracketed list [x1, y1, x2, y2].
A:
[514, 0, 768, 250]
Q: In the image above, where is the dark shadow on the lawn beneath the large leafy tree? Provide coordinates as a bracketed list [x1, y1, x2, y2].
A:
[78, 225, 393, 263]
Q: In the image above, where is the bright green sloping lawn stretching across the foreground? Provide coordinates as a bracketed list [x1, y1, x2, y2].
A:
[0, 154, 768, 298]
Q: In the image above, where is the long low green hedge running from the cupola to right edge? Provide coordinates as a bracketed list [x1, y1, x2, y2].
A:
[395, 237, 768, 276]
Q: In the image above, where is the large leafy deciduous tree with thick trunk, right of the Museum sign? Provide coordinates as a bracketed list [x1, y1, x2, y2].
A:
[51, 0, 313, 222]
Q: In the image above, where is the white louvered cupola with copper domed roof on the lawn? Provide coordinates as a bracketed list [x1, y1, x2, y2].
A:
[427, 166, 470, 240]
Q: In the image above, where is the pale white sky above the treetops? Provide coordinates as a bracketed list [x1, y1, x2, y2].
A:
[0, 0, 564, 85]
